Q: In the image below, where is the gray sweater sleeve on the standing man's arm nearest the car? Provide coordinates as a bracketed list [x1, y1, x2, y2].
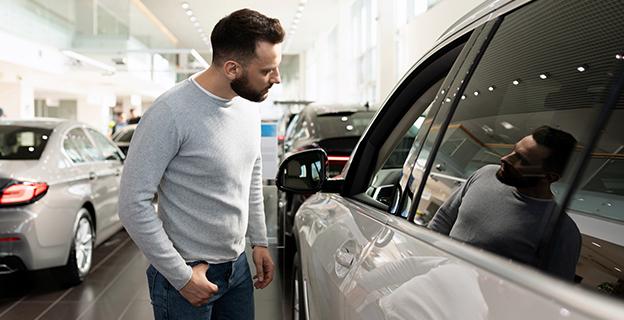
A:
[247, 155, 269, 247]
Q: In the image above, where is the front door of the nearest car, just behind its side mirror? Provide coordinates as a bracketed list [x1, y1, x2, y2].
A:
[295, 20, 476, 319]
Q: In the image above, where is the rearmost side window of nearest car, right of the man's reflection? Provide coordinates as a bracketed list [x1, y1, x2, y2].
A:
[566, 105, 624, 299]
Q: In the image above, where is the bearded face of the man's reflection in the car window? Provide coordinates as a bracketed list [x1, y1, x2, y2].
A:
[496, 135, 550, 188]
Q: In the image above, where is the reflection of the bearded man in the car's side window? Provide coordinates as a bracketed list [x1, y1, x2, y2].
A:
[429, 126, 581, 280]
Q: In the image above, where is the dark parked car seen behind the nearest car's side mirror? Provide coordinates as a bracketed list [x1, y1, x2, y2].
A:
[277, 104, 375, 276]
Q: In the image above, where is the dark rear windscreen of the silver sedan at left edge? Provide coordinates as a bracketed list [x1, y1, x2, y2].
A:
[0, 126, 52, 160]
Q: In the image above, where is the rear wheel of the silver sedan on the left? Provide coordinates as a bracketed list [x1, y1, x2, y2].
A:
[61, 208, 94, 286]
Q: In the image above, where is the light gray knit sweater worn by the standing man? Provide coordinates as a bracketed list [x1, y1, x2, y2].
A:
[119, 79, 267, 290]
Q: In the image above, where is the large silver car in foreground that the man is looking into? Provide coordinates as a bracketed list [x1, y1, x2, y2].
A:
[276, 0, 624, 319]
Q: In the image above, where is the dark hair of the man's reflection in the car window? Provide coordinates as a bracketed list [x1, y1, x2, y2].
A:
[531, 126, 576, 174]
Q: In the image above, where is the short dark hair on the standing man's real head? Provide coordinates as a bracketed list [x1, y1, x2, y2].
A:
[210, 9, 285, 64]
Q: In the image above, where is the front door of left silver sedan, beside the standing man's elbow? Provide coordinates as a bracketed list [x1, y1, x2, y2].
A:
[87, 128, 123, 241]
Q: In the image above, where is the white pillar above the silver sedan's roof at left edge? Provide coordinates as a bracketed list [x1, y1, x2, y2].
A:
[0, 81, 35, 119]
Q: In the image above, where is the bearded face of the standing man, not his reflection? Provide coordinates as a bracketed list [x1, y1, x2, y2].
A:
[230, 41, 282, 102]
